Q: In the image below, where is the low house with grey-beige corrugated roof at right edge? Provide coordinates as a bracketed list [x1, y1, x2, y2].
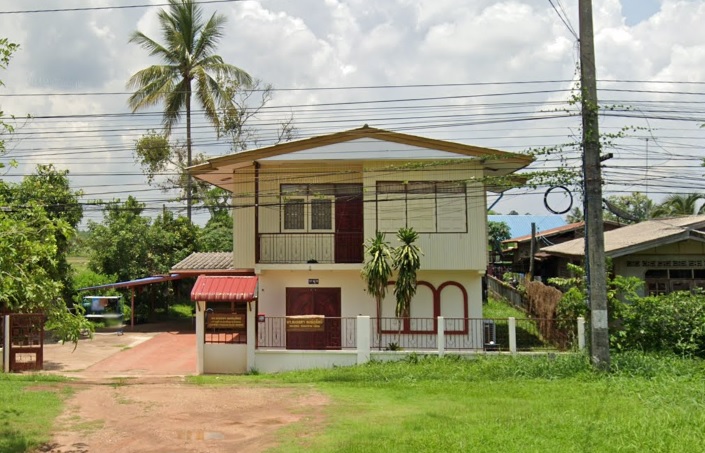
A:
[541, 215, 705, 295]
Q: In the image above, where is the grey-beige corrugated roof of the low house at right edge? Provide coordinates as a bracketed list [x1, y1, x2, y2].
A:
[541, 215, 705, 258]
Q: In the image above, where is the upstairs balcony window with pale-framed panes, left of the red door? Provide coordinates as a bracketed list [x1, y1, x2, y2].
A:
[281, 184, 335, 232]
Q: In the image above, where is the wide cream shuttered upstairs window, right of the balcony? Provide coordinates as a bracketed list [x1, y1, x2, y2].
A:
[377, 181, 468, 233]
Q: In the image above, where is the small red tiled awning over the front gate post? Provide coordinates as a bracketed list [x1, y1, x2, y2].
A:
[191, 275, 257, 302]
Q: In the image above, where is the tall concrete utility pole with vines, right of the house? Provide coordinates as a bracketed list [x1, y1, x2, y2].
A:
[579, 0, 610, 370]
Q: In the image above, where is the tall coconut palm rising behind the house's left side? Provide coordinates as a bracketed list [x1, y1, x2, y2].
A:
[127, 0, 252, 220]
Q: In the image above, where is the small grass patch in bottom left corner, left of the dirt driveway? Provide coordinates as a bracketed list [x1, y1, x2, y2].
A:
[0, 373, 70, 453]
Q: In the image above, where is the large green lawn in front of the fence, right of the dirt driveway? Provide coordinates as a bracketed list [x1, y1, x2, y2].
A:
[193, 354, 705, 452]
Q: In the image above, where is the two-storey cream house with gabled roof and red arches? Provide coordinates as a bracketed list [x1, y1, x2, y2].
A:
[190, 126, 532, 370]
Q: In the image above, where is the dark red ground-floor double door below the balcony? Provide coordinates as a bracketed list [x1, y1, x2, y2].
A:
[286, 288, 341, 349]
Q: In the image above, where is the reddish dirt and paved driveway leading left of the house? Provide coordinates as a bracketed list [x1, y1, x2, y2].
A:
[39, 329, 327, 453]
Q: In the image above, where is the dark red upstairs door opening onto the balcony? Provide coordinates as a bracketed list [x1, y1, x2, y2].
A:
[335, 186, 364, 263]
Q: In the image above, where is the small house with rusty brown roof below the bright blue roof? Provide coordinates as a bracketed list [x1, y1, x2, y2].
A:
[502, 220, 621, 278]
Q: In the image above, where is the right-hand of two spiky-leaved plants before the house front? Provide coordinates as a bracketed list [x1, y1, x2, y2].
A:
[392, 228, 421, 318]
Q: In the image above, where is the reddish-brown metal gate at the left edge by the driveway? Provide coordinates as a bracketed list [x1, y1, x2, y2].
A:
[0, 313, 44, 372]
